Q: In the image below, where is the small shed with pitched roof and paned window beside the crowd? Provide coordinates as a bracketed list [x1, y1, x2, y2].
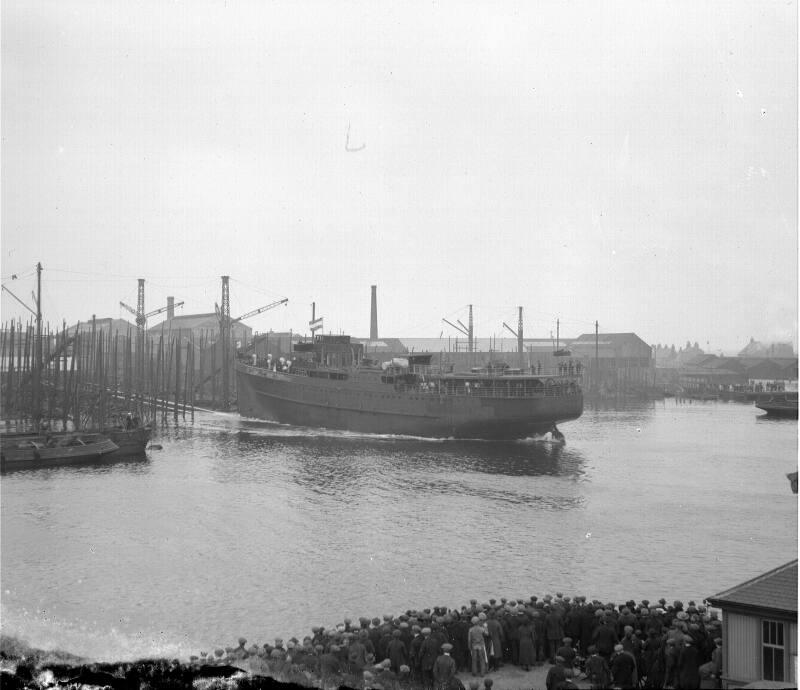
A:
[708, 559, 797, 688]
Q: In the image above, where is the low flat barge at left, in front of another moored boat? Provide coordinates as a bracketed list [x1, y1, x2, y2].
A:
[0, 432, 119, 468]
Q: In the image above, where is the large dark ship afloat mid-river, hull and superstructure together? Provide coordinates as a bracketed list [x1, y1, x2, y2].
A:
[236, 335, 583, 439]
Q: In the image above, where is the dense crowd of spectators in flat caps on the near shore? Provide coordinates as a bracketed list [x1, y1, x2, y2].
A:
[186, 593, 722, 690]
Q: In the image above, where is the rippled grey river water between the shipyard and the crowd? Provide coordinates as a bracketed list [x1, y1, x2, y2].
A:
[0, 400, 797, 660]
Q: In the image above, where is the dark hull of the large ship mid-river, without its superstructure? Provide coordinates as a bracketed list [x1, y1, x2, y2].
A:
[236, 364, 583, 440]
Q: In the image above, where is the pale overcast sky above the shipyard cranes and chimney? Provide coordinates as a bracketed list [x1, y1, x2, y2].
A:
[0, 0, 798, 354]
